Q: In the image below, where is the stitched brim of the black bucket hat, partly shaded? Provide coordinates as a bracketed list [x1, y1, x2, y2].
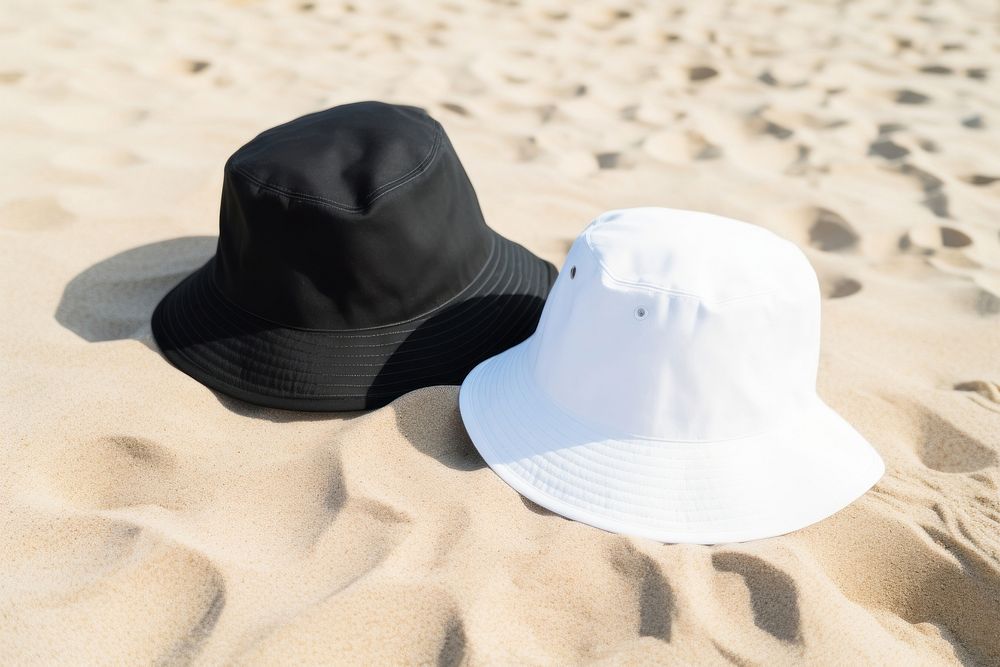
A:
[152, 235, 556, 411]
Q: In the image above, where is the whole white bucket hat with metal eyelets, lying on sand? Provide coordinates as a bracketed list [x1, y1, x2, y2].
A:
[459, 208, 885, 544]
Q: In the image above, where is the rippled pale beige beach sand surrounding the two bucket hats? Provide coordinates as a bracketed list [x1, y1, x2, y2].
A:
[0, 0, 1000, 665]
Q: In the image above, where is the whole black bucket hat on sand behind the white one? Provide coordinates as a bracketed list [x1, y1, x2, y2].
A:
[152, 102, 556, 411]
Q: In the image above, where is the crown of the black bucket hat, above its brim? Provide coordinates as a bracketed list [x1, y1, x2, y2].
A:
[214, 102, 495, 330]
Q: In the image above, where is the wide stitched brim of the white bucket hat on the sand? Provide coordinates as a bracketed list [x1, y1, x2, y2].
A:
[459, 340, 885, 544]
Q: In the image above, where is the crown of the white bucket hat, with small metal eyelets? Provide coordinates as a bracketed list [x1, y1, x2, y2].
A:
[531, 208, 819, 441]
